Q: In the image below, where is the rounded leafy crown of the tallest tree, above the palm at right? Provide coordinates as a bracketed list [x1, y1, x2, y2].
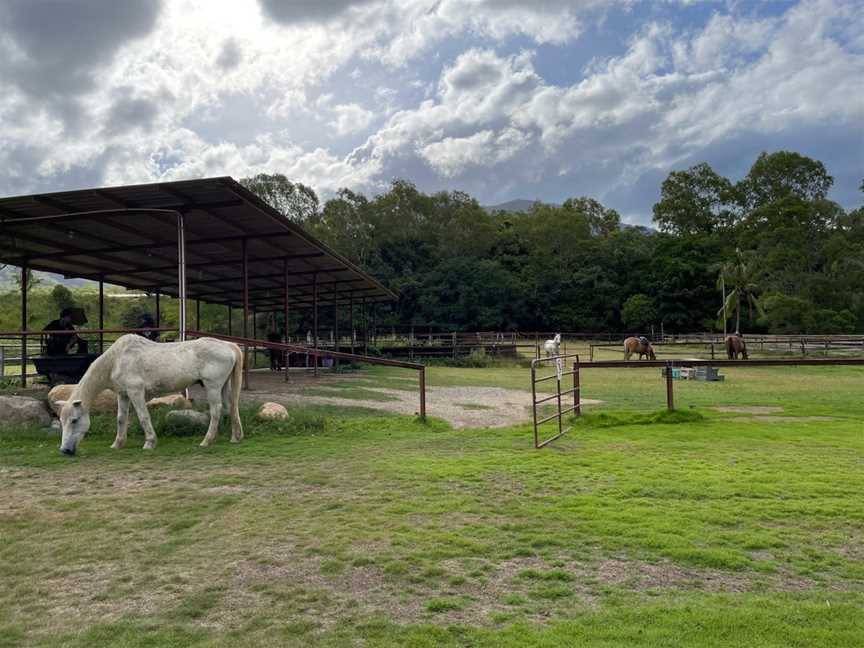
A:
[740, 151, 834, 209]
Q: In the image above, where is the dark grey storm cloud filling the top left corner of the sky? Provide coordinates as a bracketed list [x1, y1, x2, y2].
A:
[0, 0, 161, 126]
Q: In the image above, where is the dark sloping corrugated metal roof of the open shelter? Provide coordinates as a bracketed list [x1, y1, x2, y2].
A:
[0, 177, 396, 311]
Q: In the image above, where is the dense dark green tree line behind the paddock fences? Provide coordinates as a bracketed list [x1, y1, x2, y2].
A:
[242, 151, 864, 333]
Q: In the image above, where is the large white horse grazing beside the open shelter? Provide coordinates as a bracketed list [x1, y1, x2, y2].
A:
[58, 335, 243, 455]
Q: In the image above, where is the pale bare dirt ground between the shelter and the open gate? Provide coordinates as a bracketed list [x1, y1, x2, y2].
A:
[223, 372, 602, 428]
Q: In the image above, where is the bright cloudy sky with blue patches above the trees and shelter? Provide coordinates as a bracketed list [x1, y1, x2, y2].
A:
[0, 0, 864, 224]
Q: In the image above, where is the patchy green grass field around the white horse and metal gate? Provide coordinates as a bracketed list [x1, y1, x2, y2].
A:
[0, 367, 864, 648]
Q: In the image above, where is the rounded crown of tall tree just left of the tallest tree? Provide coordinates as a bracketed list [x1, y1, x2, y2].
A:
[654, 162, 739, 234]
